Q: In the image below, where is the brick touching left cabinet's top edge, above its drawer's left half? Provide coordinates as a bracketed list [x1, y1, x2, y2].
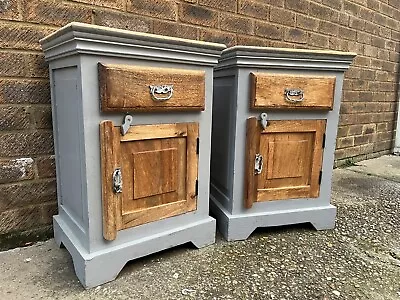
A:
[93, 10, 152, 32]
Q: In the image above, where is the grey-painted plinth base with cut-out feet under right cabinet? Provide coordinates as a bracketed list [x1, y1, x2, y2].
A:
[210, 196, 336, 241]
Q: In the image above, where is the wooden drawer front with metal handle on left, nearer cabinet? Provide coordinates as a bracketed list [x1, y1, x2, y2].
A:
[98, 63, 205, 112]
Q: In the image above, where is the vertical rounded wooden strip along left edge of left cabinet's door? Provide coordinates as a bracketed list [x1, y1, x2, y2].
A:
[100, 121, 120, 241]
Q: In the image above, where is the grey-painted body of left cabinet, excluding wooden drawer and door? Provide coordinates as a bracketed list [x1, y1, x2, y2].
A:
[41, 23, 225, 287]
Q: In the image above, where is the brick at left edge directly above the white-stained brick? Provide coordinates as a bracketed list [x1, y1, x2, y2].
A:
[0, 131, 54, 157]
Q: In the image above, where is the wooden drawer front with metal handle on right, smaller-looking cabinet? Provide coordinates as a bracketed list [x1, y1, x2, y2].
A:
[250, 73, 335, 110]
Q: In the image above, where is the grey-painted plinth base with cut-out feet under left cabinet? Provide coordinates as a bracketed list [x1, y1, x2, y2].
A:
[53, 215, 215, 288]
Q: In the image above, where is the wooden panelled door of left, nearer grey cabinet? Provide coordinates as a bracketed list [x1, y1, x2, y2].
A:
[100, 121, 199, 240]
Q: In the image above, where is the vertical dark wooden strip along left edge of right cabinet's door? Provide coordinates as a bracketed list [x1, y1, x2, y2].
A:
[244, 117, 261, 208]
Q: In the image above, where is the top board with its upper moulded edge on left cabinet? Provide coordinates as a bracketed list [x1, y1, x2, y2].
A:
[40, 22, 226, 51]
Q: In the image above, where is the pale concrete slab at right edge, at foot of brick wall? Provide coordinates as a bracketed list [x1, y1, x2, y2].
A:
[348, 155, 400, 182]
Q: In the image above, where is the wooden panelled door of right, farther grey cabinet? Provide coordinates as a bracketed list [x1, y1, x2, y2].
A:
[245, 118, 326, 208]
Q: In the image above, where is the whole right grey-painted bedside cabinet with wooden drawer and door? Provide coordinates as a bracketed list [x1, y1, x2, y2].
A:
[210, 46, 355, 240]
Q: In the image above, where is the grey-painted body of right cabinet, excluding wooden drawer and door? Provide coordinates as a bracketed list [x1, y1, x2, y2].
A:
[210, 46, 355, 240]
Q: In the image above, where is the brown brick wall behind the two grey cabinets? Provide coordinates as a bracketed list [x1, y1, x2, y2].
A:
[0, 0, 400, 236]
